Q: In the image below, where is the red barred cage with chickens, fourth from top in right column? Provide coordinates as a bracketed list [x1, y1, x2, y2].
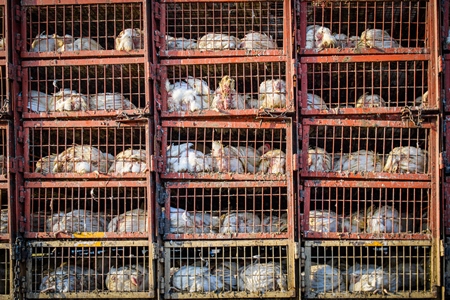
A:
[300, 181, 438, 240]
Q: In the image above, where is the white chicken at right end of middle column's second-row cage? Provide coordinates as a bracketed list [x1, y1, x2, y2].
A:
[259, 79, 286, 108]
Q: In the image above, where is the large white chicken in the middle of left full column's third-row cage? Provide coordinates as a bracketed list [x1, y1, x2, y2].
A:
[52, 145, 114, 174]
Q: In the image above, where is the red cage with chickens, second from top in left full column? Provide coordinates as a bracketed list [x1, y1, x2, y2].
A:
[20, 57, 151, 119]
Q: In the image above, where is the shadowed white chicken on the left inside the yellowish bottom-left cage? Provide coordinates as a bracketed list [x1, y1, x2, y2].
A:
[39, 264, 96, 293]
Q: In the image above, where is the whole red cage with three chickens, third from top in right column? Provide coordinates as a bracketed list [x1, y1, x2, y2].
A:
[299, 116, 439, 181]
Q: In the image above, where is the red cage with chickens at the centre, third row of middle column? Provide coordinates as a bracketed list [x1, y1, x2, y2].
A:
[160, 118, 292, 181]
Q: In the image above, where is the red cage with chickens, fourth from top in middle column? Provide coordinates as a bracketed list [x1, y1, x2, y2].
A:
[160, 181, 294, 240]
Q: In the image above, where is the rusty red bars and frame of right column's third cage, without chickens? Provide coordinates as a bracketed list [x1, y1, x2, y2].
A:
[299, 118, 439, 181]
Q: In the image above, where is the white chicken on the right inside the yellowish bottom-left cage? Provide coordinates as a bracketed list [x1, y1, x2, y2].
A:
[105, 264, 149, 292]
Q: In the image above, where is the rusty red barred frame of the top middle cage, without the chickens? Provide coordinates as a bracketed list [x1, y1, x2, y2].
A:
[153, 0, 292, 58]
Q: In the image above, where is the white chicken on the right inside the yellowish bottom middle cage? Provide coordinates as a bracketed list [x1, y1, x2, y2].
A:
[239, 262, 287, 294]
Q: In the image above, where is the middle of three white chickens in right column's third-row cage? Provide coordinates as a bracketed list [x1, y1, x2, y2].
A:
[334, 150, 383, 172]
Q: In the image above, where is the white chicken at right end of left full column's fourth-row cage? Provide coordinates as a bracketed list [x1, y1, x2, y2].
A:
[108, 209, 148, 232]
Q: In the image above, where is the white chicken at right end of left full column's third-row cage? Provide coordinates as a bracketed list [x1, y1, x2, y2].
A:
[108, 149, 147, 174]
